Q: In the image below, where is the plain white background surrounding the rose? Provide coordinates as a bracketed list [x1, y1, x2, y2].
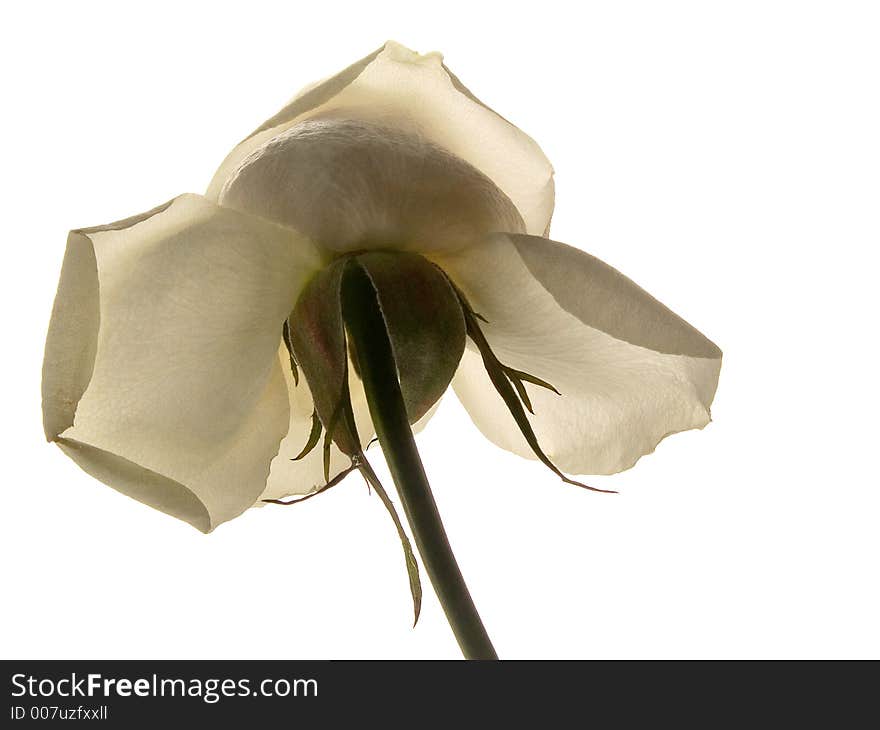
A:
[0, 0, 880, 658]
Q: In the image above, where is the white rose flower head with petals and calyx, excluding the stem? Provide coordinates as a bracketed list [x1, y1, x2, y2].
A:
[43, 43, 721, 656]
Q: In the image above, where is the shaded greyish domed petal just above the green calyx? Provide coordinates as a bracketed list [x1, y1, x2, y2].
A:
[219, 119, 525, 252]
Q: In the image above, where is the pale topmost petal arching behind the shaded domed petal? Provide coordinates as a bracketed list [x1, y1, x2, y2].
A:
[207, 42, 554, 234]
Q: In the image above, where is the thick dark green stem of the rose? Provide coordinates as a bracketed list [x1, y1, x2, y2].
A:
[342, 266, 498, 659]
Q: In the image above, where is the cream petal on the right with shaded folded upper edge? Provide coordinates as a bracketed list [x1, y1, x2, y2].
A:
[438, 235, 721, 474]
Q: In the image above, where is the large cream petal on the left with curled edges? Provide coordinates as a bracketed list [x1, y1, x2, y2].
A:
[43, 195, 320, 531]
